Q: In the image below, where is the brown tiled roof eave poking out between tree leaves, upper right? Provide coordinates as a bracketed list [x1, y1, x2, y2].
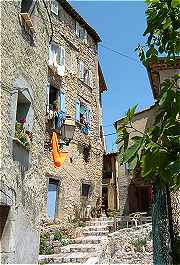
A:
[147, 57, 180, 99]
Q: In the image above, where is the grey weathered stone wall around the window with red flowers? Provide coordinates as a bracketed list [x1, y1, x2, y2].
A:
[1, 1, 49, 263]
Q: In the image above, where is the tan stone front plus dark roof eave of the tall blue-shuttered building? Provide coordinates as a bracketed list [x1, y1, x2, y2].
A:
[38, 1, 104, 220]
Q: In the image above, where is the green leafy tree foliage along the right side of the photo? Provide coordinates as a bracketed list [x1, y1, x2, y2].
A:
[116, 0, 180, 189]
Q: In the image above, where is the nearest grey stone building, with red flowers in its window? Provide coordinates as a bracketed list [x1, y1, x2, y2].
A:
[0, 0, 50, 263]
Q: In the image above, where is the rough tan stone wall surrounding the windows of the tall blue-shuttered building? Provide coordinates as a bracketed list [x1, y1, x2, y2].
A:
[41, 2, 104, 220]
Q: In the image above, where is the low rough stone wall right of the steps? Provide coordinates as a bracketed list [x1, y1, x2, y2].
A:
[102, 224, 153, 265]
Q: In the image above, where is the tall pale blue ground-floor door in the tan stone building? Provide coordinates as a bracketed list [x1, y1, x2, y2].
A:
[47, 178, 59, 219]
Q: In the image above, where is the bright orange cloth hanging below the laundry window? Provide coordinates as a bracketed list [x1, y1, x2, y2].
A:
[51, 132, 68, 167]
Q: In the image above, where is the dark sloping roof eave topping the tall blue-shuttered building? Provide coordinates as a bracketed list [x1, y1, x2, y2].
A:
[58, 0, 101, 42]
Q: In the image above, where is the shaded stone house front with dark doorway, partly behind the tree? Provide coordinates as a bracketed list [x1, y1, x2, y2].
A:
[115, 106, 155, 215]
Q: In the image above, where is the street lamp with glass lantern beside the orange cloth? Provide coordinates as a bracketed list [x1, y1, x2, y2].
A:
[61, 116, 76, 145]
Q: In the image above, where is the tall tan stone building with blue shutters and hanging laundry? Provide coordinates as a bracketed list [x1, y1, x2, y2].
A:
[41, 1, 107, 220]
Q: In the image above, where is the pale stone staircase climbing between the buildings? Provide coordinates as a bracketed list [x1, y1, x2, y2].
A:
[39, 217, 109, 265]
